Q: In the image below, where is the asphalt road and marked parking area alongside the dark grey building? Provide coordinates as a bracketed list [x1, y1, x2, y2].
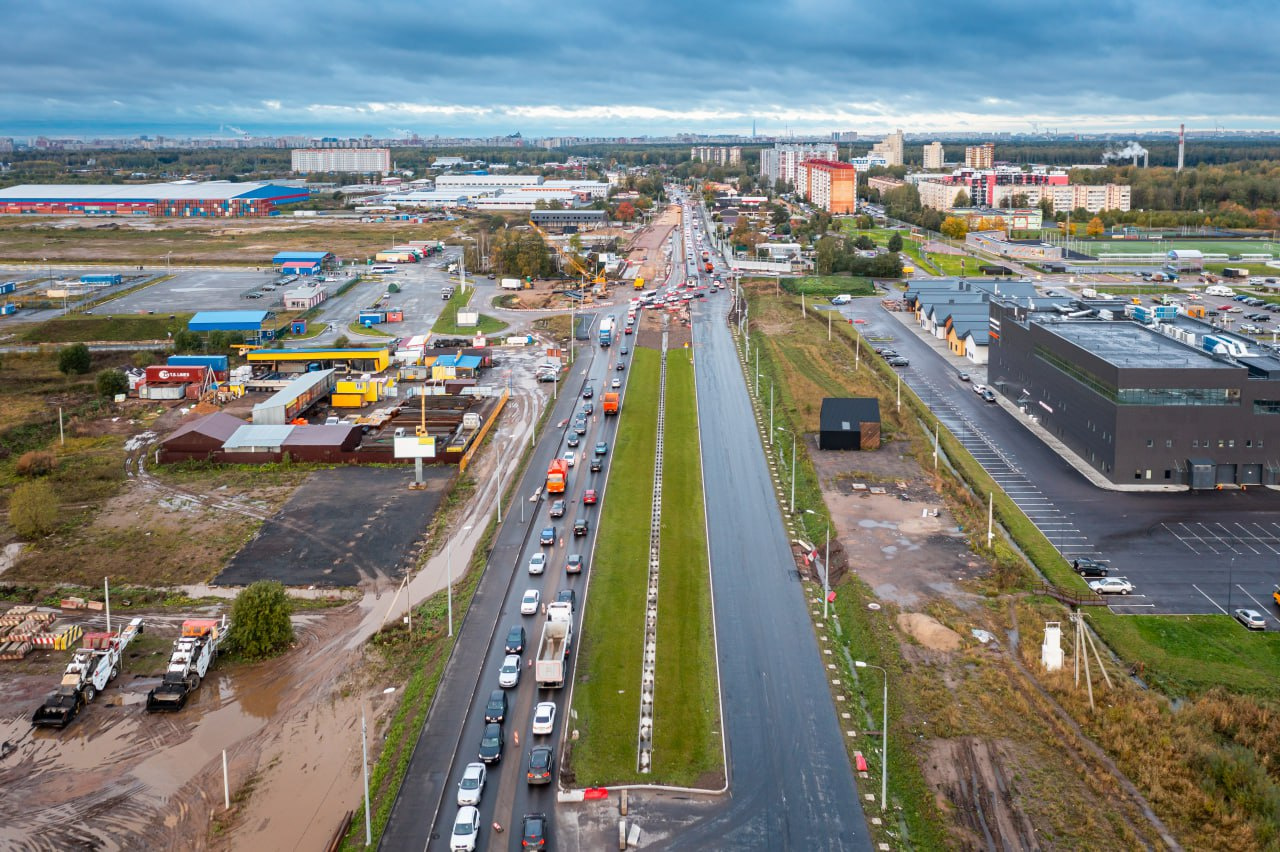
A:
[841, 299, 1280, 629]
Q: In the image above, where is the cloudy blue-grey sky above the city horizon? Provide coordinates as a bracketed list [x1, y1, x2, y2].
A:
[0, 0, 1280, 136]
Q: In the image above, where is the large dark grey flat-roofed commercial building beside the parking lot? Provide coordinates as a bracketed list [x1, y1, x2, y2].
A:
[987, 299, 1280, 489]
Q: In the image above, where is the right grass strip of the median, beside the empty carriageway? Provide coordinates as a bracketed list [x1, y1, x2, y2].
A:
[653, 349, 723, 788]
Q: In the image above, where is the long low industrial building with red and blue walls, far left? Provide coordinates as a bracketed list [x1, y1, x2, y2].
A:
[0, 180, 311, 219]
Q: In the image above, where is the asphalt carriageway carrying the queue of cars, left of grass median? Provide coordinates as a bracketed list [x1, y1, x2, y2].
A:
[381, 326, 630, 851]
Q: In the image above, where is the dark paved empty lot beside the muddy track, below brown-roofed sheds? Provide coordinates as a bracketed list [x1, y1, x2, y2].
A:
[214, 466, 456, 586]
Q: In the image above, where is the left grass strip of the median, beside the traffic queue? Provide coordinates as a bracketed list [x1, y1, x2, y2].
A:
[571, 347, 660, 787]
